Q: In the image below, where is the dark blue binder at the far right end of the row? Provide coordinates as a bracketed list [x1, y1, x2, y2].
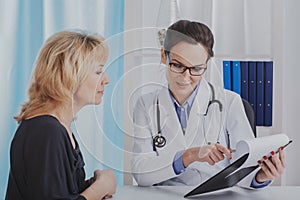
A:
[264, 61, 273, 126]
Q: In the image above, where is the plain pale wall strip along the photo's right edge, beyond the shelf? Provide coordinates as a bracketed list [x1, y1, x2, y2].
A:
[282, 0, 300, 185]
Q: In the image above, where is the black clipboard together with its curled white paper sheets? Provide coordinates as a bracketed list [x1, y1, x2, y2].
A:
[184, 134, 292, 198]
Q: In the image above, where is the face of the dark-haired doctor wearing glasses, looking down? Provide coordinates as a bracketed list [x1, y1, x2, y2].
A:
[162, 42, 208, 104]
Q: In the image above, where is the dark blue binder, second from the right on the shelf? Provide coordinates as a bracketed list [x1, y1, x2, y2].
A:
[256, 61, 265, 126]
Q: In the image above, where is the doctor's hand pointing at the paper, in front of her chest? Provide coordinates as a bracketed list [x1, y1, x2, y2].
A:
[182, 144, 231, 167]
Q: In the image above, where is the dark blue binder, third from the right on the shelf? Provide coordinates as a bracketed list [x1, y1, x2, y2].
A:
[249, 61, 256, 111]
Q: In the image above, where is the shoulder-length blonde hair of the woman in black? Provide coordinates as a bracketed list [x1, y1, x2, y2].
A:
[15, 31, 108, 123]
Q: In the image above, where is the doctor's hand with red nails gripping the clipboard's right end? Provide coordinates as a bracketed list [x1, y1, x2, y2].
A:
[255, 147, 285, 183]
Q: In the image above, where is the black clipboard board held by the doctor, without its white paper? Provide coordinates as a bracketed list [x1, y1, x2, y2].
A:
[184, 140, 292, 198]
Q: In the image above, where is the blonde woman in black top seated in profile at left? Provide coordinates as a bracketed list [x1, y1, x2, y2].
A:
[5, 31, 116, 200]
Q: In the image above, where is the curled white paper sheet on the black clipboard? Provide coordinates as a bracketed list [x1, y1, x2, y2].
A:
[232, 134, 289, 167]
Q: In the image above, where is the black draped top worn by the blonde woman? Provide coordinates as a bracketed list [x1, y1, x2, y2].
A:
[5, 115, 89, 200]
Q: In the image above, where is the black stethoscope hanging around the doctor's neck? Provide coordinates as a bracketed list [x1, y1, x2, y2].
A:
[152, 82, 223, 155]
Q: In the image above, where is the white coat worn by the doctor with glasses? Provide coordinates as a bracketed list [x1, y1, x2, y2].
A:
[131, 78, 256, 187]
